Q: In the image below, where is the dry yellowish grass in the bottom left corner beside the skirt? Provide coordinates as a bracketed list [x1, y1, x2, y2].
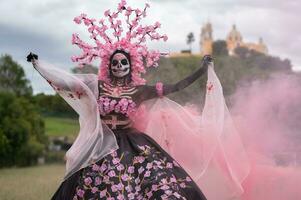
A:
[0, 165, 65, 200]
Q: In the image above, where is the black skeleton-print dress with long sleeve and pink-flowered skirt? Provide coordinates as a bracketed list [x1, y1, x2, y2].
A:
[52, 68, 206, 200]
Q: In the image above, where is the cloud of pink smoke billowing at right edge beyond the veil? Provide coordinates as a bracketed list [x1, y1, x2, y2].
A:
[231, 75, 301, 200]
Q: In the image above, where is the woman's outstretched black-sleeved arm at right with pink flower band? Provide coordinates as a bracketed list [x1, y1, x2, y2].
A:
[139, 55, 213, 101]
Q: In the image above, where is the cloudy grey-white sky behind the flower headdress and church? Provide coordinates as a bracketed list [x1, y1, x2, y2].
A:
[0, 0, 301, 93]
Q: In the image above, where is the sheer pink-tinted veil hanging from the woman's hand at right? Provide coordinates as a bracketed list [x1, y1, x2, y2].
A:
[133, 66, 250, 200]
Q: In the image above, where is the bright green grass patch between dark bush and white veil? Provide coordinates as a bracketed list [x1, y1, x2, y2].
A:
[44, 117, 79, 139]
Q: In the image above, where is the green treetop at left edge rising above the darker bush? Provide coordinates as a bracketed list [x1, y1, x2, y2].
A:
[0, 55, 32, 96]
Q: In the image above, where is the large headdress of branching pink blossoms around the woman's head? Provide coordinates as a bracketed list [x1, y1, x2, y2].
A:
[71, 0, 168, 85]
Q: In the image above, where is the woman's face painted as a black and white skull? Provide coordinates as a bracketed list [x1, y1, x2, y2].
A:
[111, 53, 130, 78]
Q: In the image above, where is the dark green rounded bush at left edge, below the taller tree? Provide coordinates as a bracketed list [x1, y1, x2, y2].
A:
[0, 92, 47, 167]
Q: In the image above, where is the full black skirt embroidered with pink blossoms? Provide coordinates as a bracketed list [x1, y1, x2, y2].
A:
[52, 129, 206, 200]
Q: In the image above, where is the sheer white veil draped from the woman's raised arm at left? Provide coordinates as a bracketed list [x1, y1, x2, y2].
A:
[34, 61, 118, 179]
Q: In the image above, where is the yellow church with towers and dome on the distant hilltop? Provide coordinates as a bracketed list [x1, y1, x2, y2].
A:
[170, 22, 268, 57]
